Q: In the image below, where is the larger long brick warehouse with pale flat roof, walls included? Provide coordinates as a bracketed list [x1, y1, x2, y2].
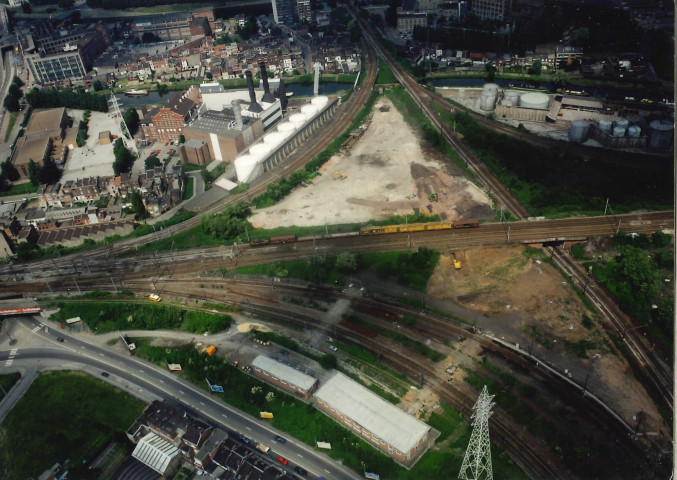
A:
[315, 372, 432, 466]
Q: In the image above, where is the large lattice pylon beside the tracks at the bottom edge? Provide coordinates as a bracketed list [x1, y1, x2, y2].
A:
[458, 385, 494, 480]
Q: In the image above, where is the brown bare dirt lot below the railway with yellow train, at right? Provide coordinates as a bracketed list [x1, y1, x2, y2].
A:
[427, 246, 669, 432]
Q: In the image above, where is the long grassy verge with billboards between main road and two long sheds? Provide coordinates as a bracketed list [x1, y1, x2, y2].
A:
[132, 338, 526, 480]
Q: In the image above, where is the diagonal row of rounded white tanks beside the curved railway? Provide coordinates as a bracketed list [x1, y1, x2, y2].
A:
[235, 96, 329, 182]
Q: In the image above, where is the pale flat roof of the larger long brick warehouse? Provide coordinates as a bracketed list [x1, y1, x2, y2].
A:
[315, 372, 430, 454]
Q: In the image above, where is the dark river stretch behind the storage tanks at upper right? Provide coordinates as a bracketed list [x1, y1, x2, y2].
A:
[431, 77, 673, 102]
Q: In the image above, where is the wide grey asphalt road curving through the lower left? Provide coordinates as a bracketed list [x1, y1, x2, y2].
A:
[0, 317, 360, 479]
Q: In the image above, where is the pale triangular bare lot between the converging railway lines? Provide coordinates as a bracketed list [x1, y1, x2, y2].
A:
[251, 98, 493, 228]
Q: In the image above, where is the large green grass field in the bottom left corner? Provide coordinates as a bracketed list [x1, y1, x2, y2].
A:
[0, 372, 145, 479]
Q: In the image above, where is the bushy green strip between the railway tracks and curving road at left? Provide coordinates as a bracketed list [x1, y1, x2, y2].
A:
[51, 298, 232, 334]
